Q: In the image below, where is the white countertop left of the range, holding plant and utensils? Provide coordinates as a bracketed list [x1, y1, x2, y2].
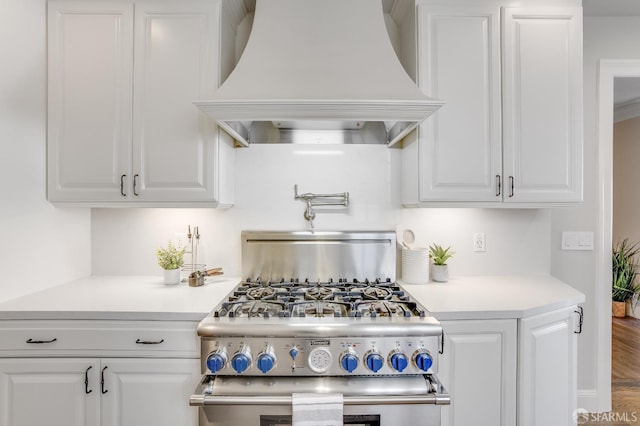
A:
[0, 276, 240, 321]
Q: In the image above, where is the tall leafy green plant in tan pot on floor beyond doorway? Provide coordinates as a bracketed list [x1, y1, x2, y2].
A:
[611, 238, 640, 317]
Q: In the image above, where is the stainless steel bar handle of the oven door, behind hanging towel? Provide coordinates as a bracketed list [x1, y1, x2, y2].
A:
[189, 375, 451, 407]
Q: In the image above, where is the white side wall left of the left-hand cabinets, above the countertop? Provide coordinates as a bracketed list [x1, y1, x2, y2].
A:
[0, 0, 90, 301]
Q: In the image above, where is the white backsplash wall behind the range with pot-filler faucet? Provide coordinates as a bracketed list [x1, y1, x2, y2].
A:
[92, 145, 550, 275]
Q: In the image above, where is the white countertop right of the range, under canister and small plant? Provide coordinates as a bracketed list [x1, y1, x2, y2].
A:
[399, 275, 585, 320]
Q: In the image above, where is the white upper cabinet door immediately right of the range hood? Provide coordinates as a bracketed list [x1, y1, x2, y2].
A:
[418, 5, 502, 201]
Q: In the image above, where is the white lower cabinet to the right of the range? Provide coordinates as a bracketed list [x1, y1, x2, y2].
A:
[438, 306, 581, 426]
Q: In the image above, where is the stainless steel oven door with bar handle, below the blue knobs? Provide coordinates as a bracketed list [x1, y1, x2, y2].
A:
[190, 374, 451, 426]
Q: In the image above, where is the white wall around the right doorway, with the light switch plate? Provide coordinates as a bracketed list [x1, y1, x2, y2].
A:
[551, 17, 640, 410]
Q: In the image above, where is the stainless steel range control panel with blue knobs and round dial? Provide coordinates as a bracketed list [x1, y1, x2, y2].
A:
[202, 336, 438, 376]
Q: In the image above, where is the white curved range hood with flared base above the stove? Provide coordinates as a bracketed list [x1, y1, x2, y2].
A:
[194, 0, 443, 146]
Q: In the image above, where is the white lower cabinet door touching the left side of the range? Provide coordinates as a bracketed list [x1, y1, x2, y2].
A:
[101, 358, 200, 426]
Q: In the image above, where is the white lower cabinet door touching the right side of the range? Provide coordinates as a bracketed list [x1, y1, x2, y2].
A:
[438, 320, 516, 426]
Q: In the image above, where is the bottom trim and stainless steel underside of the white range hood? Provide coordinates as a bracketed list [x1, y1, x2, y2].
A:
[195, 99, 443, 146]
